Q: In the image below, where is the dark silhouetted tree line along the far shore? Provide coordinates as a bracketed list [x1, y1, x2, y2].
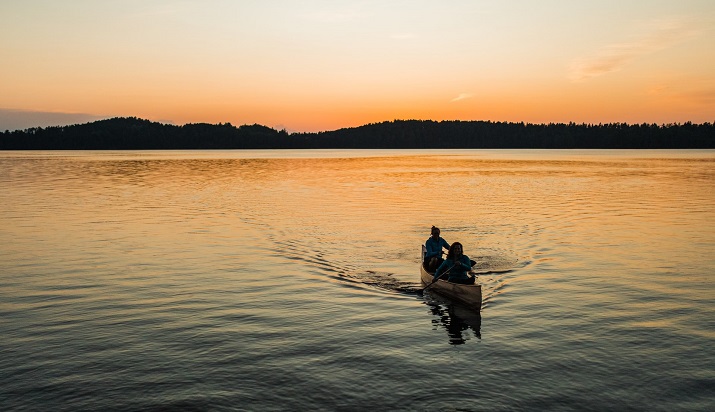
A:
[0, 117, 715, 150]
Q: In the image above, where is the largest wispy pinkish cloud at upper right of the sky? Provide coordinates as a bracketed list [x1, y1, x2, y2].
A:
[569, 20, 697, 82]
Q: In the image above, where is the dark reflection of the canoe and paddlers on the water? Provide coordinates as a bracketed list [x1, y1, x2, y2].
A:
[427, 302, 482, 345]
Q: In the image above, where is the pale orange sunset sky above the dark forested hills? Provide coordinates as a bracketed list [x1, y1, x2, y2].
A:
[0, 0, 715, 132]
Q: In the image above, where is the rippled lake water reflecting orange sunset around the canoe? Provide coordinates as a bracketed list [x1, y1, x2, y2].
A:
[0, 150, 715, 411]
